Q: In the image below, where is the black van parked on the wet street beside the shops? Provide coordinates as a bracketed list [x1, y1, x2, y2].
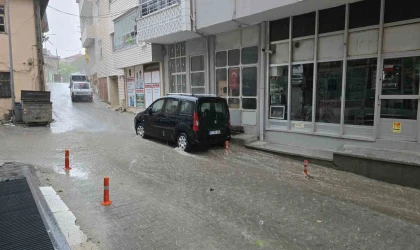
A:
[134, 94, 230, 151]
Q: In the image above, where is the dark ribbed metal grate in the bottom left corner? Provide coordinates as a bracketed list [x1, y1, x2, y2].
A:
[0, 179, 54, 249]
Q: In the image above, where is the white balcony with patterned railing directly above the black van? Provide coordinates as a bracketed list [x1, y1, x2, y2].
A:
[137, 0, 200, 44]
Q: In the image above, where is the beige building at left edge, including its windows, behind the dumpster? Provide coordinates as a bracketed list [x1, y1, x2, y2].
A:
[0, 0, 48, 119]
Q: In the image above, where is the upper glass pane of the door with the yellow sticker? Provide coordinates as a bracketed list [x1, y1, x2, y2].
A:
[382, 57, 420, 95]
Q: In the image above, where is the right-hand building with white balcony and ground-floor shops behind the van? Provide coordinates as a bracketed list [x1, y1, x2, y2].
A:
[137, 0, 420, 151]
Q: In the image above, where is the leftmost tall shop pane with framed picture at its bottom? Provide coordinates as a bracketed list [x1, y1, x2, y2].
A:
[268, 66, 289, 120]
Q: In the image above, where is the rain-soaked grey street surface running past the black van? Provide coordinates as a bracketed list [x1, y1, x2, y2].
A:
[0, 83, 420, 249]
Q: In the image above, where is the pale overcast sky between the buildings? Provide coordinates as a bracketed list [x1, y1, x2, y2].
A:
[46, 0, 84, 58]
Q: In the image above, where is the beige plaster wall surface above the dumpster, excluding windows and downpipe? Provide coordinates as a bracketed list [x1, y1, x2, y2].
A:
[0, 0, 39, 116]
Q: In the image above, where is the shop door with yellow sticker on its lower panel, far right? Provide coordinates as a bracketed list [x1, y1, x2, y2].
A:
[379, 57, 420, 142]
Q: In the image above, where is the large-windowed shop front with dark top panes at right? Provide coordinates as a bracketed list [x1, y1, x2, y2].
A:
[265, 0, 420, 148]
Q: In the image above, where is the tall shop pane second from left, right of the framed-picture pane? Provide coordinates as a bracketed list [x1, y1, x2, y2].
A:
[290, 63, 314, 121]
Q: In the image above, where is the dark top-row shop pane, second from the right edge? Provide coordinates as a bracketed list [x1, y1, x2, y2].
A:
[349, 0, 381, 29]
